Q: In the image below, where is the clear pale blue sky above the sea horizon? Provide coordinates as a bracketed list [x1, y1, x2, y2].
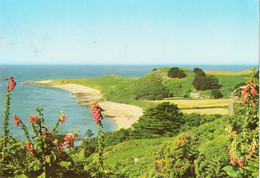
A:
[0, 0, 259, 65]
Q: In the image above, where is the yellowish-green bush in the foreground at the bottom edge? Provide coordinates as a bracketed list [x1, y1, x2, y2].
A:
[153, 133, 198, 177]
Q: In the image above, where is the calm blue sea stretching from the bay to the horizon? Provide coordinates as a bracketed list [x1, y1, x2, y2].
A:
[0, 65, 258, 145]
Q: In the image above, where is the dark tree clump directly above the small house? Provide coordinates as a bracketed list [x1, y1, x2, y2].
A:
[192, 68, 222, 91]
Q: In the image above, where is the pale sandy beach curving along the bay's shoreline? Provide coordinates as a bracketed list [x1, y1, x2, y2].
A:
[32, 80, 143, 130]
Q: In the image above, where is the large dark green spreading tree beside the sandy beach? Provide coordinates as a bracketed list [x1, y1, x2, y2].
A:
[133, 102, 184, 138]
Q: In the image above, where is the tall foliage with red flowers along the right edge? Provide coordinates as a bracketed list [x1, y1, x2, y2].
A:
[224, 69, 259, 177]
